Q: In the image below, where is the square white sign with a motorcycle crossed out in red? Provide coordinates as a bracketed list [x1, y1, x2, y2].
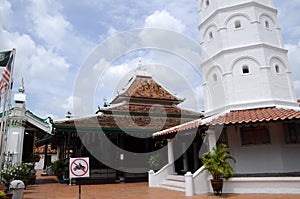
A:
[70, 158, 90, 178]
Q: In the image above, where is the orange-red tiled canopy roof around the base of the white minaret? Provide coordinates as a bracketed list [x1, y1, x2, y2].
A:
[153, 107, 300, 136]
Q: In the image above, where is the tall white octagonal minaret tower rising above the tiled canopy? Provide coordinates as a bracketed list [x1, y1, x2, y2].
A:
[198, 0, 297, 116]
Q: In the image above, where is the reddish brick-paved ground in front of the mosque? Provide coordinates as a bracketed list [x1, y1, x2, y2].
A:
[23, 171, 300, 199]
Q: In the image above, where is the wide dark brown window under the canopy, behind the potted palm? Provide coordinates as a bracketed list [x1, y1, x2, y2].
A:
[241, 126, 271, 145]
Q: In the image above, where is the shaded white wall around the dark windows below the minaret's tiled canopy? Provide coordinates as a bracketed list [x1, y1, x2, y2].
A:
[227, 123, 300, 174]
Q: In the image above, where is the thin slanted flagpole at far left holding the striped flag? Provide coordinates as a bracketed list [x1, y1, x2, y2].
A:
[0, 48, 16, 169]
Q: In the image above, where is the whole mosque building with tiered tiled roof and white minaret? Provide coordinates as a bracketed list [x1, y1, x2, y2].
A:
[5, 0, 300, 196]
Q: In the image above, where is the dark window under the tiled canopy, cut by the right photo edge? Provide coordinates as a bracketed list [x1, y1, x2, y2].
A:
[284, 122, 300, 144]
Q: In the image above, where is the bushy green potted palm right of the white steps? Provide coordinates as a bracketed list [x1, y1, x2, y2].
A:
[202, 144, 236, 195]
